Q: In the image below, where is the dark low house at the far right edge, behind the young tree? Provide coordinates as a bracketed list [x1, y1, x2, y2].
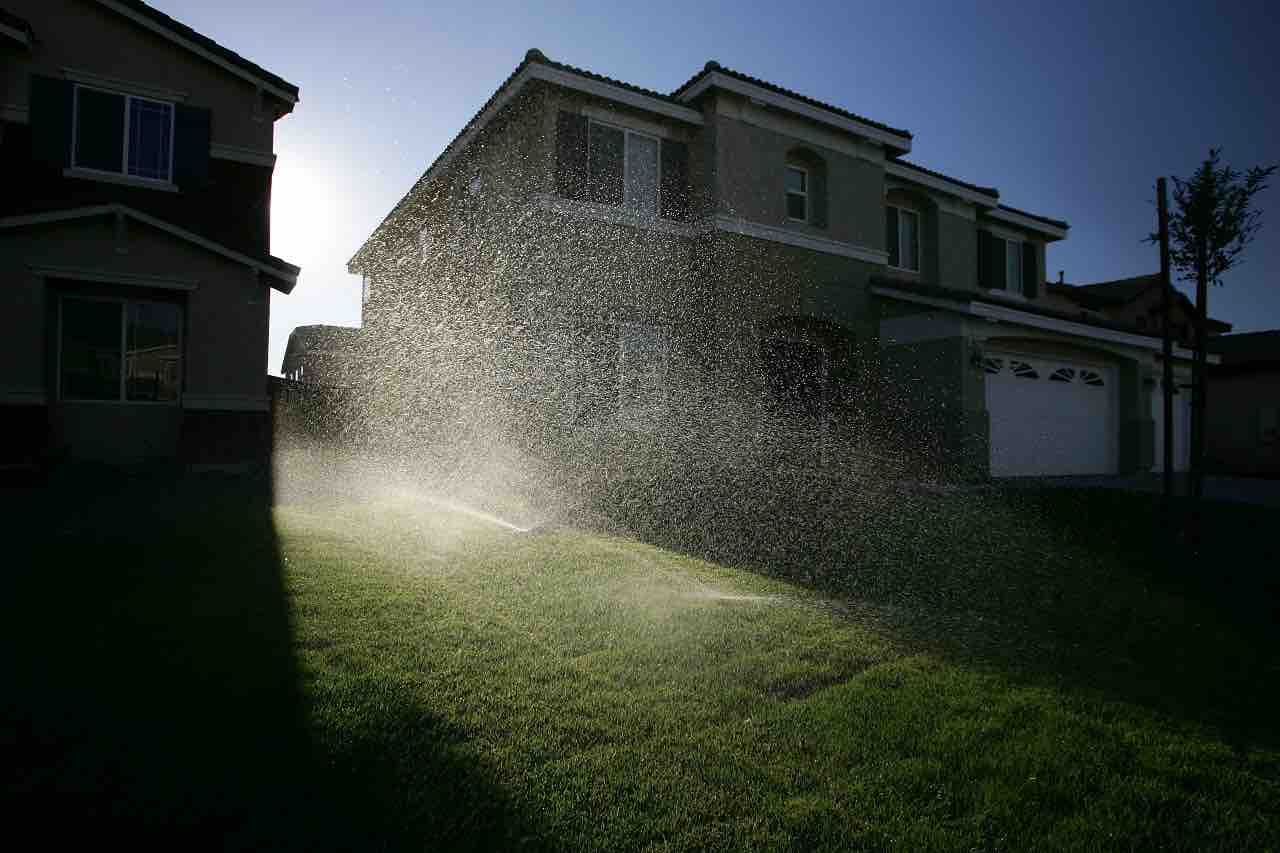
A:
[1204, 329, 1280, 476]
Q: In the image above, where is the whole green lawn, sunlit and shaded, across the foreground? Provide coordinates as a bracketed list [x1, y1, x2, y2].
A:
[0, 468, 1280, 850]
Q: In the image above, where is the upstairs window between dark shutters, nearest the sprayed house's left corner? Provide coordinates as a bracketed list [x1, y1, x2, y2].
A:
[586, 122, 662, 216]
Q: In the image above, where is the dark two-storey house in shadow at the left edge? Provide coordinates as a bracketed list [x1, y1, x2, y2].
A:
[0, 0, 298, 461]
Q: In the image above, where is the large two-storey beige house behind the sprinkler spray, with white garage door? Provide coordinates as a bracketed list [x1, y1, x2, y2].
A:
[348, 50, 1208, 476]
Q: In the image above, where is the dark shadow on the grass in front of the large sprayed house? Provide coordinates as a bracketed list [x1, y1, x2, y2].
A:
[586, 470, 1280, 747]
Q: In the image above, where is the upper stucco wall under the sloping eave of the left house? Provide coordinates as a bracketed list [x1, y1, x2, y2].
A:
[0, 0, 280, 152]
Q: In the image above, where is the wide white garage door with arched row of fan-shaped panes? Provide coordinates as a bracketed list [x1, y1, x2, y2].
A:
[983, 353, 1117, 476]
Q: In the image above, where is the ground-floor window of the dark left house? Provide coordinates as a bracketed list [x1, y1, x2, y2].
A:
[58, 296, 182, 402]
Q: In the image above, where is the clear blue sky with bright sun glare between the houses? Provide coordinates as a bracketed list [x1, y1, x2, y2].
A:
[151, 0, 1280, 373]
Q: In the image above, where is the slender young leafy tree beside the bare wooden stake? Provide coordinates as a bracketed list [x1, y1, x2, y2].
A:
[1169, 149, 1276, 500]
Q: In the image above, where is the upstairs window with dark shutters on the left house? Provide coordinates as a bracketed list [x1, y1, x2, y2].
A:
[72, 86, 174, 182]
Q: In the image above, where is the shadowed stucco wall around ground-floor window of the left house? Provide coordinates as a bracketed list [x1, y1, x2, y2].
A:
[0, 216, 270, 409]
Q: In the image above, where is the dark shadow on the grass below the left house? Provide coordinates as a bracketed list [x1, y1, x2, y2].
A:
[0, 469, 560, 849]
